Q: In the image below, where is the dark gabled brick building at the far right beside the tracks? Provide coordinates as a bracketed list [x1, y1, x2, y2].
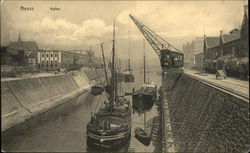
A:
[204, 5, 249, 76]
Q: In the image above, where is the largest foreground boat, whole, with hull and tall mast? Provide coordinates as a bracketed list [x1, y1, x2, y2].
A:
[87, 20, 131, 149]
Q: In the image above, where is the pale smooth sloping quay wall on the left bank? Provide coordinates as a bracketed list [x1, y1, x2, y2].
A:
[1, 69, 100, 131]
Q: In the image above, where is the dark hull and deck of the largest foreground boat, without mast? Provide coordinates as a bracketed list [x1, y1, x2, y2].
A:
[87, 97, 131, 149]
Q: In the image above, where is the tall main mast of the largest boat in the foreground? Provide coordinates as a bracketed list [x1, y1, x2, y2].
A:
[109, 21, 115, 112]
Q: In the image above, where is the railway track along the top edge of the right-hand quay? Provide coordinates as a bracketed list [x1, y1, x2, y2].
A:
[185, 73, 249, 102]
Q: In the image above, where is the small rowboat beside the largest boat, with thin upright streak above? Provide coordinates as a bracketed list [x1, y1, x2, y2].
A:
[135, 112, 150, 146]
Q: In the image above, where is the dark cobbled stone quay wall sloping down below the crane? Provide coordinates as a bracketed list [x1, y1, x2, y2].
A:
[162, 70, 250, 153]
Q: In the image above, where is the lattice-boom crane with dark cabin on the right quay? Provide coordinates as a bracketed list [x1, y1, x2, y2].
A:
[129, 15, 184, 69]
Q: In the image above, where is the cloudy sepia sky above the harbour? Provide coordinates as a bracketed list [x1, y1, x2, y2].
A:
[1, 0, 248, 66]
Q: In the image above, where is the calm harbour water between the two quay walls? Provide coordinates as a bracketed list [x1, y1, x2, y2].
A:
[1, 65, 161, 152]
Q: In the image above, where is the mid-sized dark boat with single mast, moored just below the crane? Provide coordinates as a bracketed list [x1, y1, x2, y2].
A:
[132, 41, 157, 113]
